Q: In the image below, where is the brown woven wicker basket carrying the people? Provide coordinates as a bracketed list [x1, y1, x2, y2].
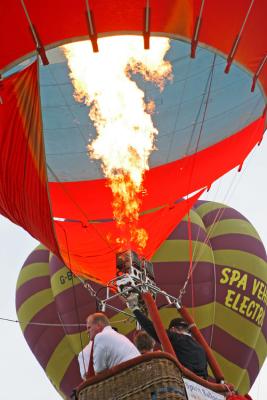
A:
[78, 358, 186, 400]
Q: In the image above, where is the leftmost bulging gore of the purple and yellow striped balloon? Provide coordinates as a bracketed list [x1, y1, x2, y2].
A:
[16, 245, 86, 398]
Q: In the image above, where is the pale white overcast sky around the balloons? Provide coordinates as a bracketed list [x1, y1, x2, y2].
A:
[0, 139, 267, 400]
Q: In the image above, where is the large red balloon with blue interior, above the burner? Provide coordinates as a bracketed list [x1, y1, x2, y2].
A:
[0, 0, 267, 283]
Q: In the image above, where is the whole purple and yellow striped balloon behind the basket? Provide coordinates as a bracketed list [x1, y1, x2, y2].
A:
[16, 201, 267, 395]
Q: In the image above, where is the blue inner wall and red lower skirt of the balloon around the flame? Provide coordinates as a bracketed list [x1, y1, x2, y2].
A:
[0, 39, 265, 283]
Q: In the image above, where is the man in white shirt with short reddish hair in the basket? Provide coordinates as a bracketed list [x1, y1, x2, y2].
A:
[80, 313, 140, 377]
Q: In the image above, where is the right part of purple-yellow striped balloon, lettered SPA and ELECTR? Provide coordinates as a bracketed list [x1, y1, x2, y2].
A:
[153, 201, 267, 393]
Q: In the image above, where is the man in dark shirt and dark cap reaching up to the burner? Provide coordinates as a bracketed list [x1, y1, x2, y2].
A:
[127, 294, 208, 379]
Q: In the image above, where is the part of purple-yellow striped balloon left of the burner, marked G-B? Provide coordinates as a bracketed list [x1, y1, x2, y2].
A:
[16, 245, 132, 399]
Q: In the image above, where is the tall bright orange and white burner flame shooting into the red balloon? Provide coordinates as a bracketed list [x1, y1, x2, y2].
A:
[63, 36, 172, 250]
